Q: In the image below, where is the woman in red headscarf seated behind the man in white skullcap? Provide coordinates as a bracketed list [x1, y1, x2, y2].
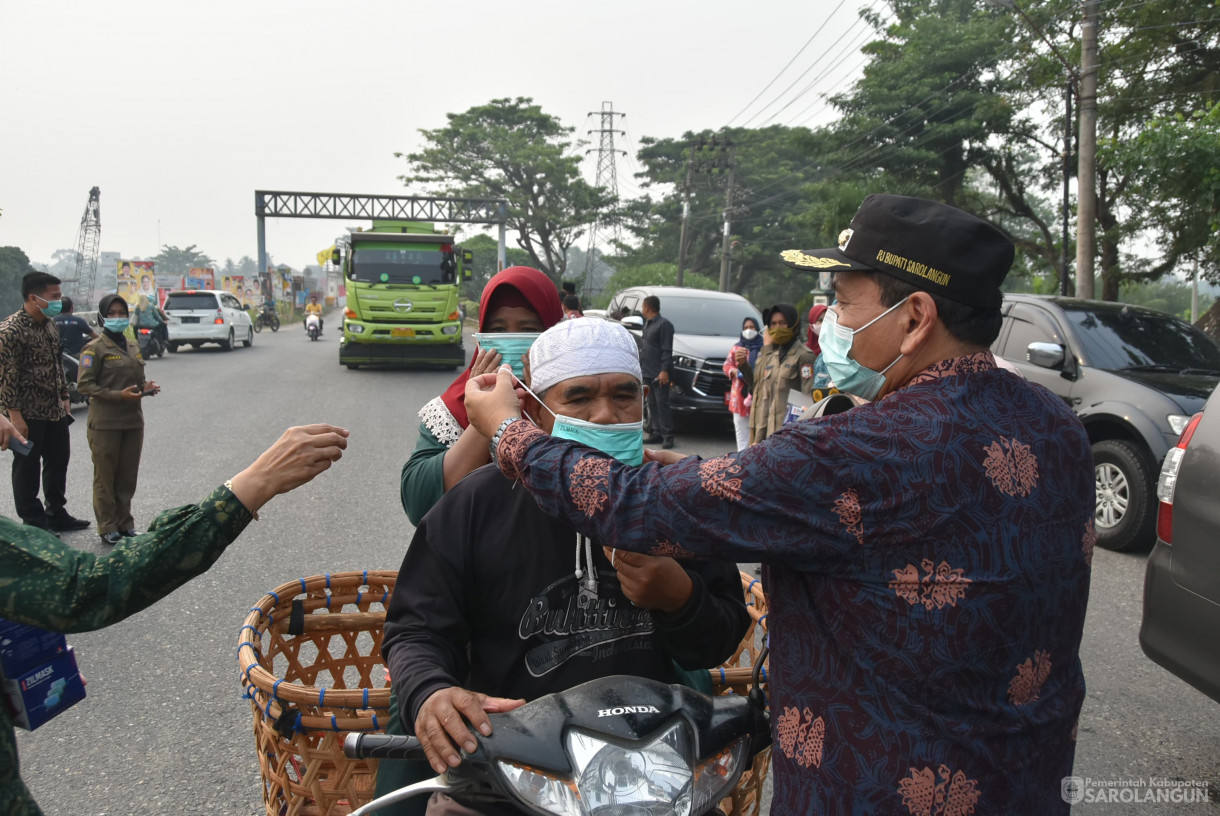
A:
[399, 266, 564, 524]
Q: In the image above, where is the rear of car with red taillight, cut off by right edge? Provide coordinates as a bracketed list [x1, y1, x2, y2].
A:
[1139, 392, 1220, 700]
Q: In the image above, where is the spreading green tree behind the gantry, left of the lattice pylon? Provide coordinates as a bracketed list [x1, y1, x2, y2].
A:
[394, 96, 617, 281]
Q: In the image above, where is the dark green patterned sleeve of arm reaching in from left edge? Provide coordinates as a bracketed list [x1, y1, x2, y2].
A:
[0, 488, 253, 632]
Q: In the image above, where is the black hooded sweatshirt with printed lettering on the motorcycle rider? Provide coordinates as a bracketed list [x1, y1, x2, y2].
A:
[382, 465, 749, 733]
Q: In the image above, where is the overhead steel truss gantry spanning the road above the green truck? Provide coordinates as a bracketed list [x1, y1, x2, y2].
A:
[254, 190, 509, 278]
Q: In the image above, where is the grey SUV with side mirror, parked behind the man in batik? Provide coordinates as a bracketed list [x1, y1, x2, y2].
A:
[992, 295, 1220, 550]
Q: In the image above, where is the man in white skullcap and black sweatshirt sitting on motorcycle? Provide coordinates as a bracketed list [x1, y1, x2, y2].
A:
[382, 317, 749, 816]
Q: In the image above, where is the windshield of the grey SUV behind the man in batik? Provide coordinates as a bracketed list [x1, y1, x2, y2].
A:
[1064, 307, 1220, 371]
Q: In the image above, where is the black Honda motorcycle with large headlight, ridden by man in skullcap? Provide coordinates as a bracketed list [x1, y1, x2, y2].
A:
[343, 661, 771, 816]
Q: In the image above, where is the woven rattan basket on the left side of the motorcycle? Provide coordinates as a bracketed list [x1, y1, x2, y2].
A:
[238, 571, 398, 816]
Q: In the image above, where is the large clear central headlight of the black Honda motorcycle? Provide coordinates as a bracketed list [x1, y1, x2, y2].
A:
[567, 723, 694, 816]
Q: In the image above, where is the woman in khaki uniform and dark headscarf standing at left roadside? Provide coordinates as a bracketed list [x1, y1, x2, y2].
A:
[77, 295, 161, 544]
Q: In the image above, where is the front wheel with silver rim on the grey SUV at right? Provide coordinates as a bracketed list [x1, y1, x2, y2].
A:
[1093, 439, 1157, 553]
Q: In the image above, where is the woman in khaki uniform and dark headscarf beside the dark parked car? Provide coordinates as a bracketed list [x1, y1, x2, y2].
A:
[739, 304, 817, 445]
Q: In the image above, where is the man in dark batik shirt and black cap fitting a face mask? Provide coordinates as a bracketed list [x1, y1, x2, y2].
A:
[466, 195, 1094, 816]
